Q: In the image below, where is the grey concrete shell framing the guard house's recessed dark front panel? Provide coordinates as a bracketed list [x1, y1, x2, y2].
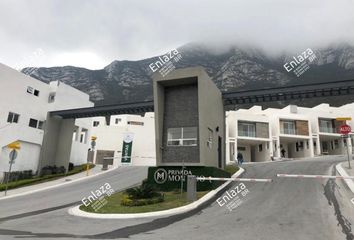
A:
[153, 67, 225, 167]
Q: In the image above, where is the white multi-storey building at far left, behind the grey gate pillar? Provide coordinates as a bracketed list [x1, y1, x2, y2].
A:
[0, 63, 94, 178]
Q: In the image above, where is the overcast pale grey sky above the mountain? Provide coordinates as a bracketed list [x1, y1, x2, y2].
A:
[0, 0, 354, 69]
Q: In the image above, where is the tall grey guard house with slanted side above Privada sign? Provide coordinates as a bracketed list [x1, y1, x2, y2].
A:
[153, 67, 225, 168]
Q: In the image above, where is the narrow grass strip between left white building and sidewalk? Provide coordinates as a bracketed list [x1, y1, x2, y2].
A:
[0, 164, 95, 192]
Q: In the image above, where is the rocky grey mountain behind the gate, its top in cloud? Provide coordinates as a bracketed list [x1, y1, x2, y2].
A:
[22, 43, 354, 106]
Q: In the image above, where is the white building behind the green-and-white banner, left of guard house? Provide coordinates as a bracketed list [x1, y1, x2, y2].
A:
[92, 113, 156, 166]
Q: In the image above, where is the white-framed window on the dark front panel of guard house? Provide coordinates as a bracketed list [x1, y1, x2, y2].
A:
[167, 127, 198, 146]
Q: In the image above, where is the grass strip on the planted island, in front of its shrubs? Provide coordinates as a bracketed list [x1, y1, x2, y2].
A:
[80, 191, 208, 213]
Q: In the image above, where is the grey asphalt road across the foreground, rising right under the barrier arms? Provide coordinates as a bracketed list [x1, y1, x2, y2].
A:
[0, 158, 354, 240]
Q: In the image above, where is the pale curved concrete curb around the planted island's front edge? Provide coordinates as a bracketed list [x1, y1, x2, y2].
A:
[68, 168, 245, 219]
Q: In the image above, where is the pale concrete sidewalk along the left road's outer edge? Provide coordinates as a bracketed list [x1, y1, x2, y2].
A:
[0, 165, 116, 200]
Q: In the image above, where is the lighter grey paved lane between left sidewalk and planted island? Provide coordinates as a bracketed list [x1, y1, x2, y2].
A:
[0, 167, 147, 219]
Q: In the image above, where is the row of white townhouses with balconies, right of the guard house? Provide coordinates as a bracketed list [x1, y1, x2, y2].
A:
[226, 103, 354, 163]
